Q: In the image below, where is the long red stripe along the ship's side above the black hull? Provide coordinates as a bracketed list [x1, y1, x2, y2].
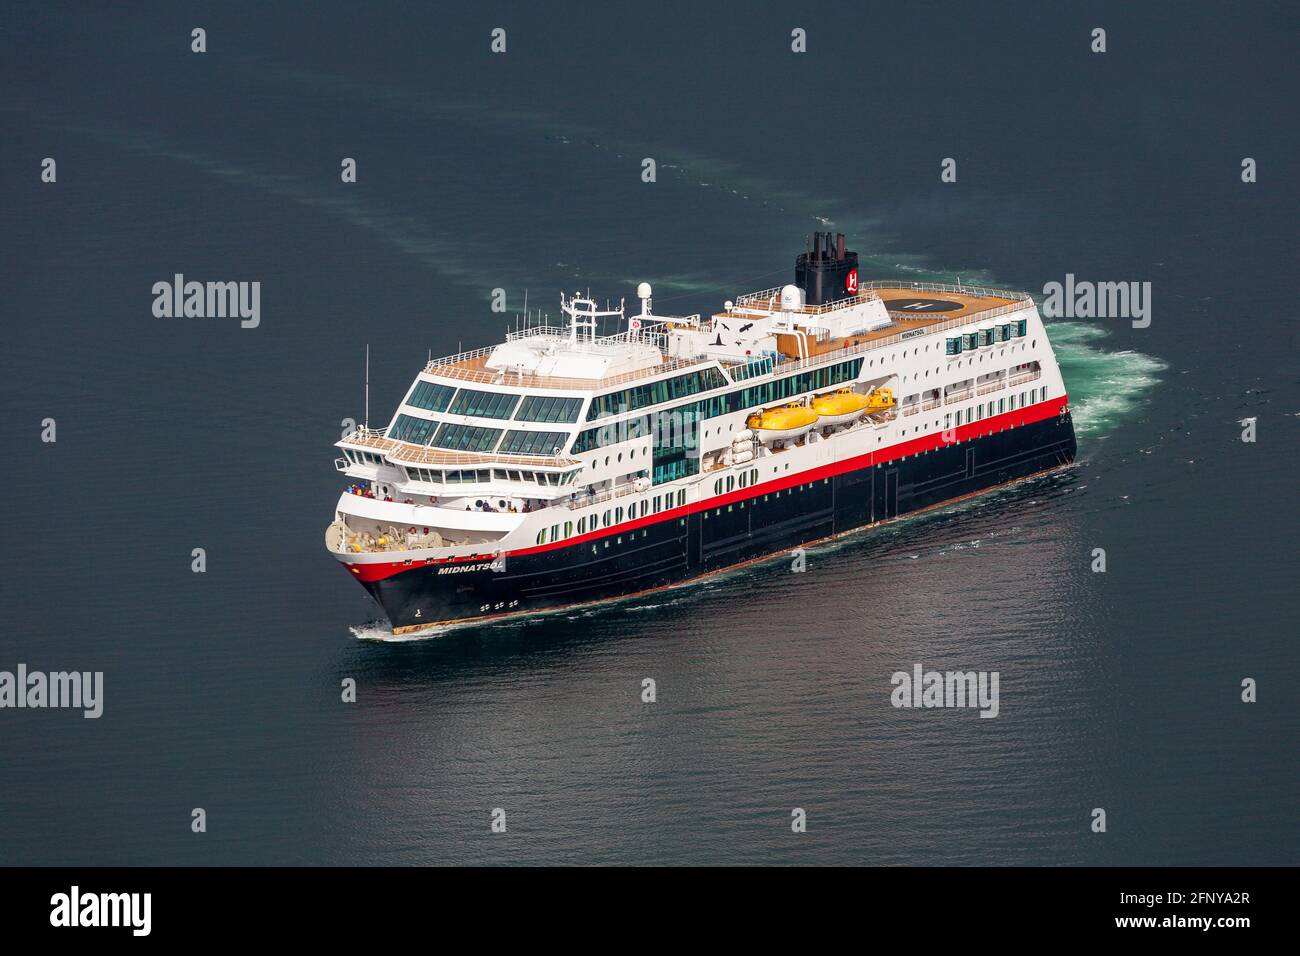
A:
[347, 395, 1070, 581]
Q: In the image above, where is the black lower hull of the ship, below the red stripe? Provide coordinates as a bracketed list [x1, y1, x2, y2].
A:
[348, 411, 1076, 633]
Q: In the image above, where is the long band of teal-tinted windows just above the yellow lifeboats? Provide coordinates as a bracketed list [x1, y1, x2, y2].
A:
[572, 359, 862, 454]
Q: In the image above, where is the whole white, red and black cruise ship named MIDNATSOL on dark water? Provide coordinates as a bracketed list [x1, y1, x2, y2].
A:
[325, 233, 1075, 633]
